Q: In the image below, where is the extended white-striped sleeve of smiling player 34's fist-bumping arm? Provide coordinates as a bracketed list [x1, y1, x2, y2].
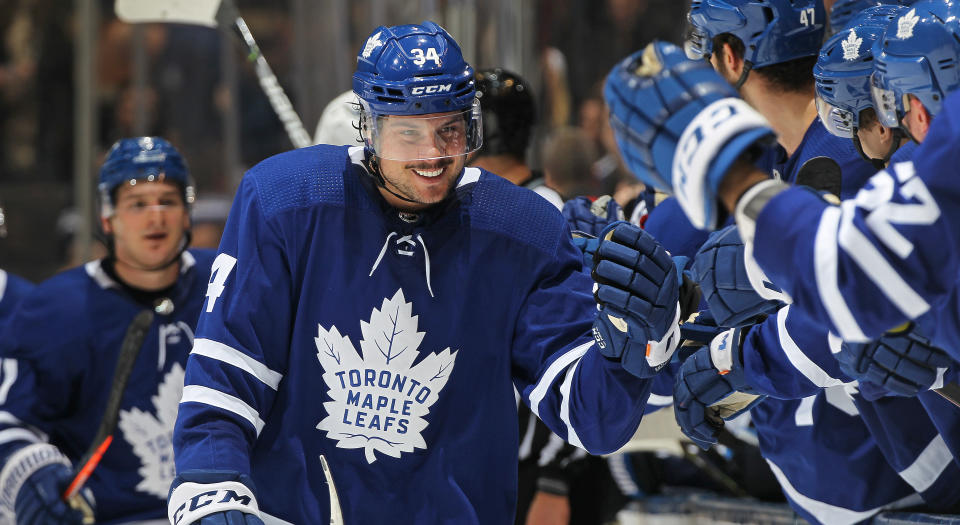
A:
[513, 213, 652, 454]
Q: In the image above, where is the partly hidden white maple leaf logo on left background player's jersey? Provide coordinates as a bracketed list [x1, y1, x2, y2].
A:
[117, 363, 184, 499]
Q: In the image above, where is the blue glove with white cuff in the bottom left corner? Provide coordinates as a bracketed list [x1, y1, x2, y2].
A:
[0, 443, 93, 525]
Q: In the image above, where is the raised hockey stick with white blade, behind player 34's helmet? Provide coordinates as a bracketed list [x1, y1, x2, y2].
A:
[114, 0, 312, 148]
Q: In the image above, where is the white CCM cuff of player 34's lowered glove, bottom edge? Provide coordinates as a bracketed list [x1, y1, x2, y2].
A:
[167, 475, 260, 525]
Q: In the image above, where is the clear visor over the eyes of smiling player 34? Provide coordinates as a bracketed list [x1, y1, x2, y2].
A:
[361, 99, 483, 161]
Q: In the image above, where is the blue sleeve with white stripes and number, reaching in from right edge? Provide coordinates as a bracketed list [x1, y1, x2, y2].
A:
[754, 93, 960, 341]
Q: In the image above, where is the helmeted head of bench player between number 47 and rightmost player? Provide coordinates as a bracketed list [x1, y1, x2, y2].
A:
[813, 5, 907, 169]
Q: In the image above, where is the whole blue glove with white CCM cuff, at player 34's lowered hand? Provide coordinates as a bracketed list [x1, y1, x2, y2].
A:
[167, 470, 264, 525]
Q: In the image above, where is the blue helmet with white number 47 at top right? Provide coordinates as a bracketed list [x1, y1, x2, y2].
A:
[686, 0, 827, 68]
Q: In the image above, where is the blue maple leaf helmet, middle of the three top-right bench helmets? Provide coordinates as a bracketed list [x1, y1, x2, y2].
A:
[813, 5, 907, 138]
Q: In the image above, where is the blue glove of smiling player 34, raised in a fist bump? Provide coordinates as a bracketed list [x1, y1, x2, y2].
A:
[593, 222, 680, 377]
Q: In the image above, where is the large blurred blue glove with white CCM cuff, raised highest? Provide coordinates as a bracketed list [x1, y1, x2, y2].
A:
[604, 41, 774, 229]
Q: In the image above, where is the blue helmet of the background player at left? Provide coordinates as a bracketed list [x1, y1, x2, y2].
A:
[97, 137, 196, 219]
